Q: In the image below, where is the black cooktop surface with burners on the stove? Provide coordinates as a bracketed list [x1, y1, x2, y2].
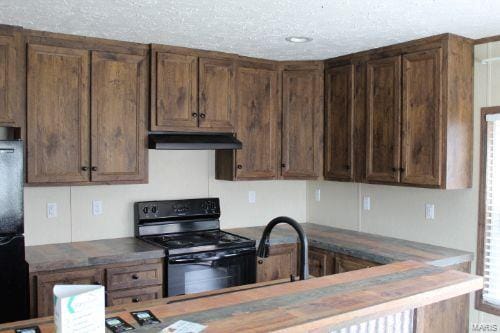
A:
[144, 230, 251, 250]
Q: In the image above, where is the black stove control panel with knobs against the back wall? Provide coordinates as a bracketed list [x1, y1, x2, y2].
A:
[135, 198, 220, 221]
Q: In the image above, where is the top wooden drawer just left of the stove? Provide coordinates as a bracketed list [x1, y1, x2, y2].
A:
[106, 264, 163, 290]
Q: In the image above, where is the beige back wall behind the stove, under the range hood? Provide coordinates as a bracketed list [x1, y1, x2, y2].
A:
[25, 150, 306, 245]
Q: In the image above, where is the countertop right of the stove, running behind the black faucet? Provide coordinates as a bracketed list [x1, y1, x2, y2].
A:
[225, 223, 474, 267]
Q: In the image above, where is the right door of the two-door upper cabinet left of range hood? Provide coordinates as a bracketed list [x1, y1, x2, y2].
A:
[91, 52, 148, 182]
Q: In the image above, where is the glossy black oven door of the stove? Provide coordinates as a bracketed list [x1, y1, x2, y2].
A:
[167, 248, 256, 296]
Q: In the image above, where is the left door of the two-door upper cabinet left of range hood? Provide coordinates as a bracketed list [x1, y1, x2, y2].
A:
[27, 44, 90, 183]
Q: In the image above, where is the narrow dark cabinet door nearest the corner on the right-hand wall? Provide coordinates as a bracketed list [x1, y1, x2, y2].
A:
[325, 65, 355, 181]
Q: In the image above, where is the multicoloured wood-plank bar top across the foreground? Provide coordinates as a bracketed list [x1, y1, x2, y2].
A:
[0, 261, 483, 333]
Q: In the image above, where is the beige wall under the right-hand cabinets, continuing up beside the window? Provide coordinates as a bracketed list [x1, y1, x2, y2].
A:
[307, 42, 500, 325]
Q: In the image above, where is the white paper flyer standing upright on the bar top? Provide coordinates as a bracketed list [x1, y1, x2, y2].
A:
[54, 285, 105, 333]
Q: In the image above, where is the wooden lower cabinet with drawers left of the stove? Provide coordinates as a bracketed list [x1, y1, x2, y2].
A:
[30, 259, 163, 318]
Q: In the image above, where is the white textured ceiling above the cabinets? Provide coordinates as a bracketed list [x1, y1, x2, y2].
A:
[0, 0, 500, 60]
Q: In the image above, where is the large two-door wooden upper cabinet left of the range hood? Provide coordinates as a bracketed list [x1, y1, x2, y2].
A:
[26, 31, 149, 185]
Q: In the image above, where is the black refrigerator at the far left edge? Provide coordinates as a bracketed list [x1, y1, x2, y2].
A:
[0, 140, 29, 323]
